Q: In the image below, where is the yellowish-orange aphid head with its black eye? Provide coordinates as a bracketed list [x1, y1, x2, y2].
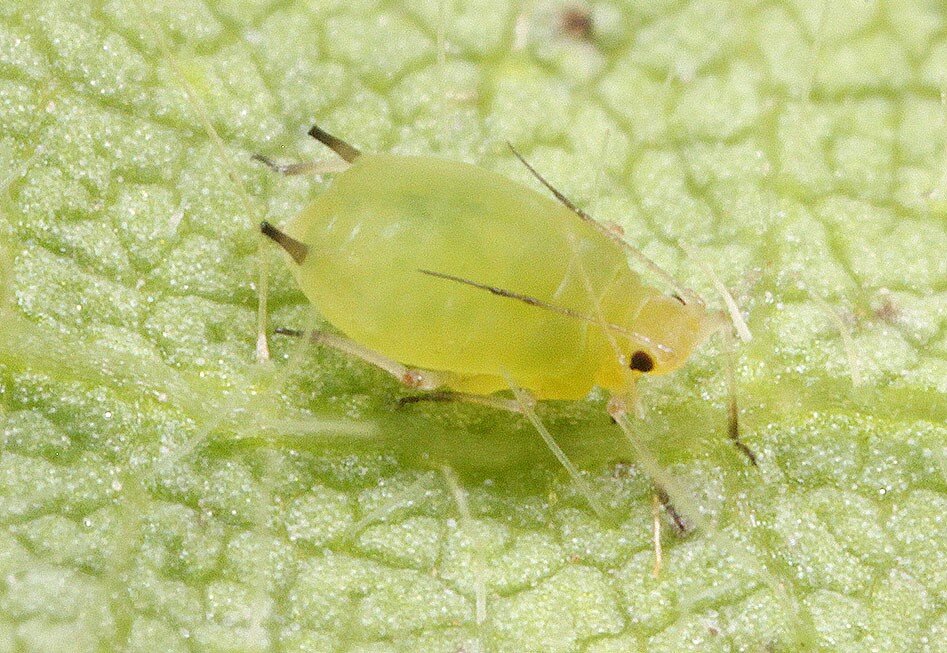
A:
[627, 294, 707, 374]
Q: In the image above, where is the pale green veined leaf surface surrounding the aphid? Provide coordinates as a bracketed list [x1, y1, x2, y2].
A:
[0, 0, 947, 653]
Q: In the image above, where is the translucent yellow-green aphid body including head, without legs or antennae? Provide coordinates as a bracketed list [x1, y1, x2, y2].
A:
[287, 154, 701, 399]
